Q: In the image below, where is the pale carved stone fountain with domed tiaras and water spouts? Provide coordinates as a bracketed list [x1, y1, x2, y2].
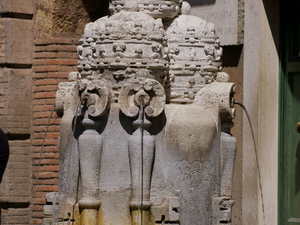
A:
[47, 0, 236, 225]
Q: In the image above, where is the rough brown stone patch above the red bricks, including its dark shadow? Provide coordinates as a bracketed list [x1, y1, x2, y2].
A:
[34, 0, 109, 38]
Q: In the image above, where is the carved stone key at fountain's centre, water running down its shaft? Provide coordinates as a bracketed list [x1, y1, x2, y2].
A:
[119, 79, 166, 208]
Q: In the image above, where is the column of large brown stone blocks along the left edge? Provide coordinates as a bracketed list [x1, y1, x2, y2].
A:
[0, 0, 34, 225]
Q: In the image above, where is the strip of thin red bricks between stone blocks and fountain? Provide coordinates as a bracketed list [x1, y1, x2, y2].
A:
[32, 38, 79, 224]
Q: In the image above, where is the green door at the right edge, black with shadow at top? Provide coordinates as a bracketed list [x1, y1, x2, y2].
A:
[278, 0, 300, 225]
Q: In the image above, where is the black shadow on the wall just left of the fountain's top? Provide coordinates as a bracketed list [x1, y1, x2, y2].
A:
[81, 0, 109, 21]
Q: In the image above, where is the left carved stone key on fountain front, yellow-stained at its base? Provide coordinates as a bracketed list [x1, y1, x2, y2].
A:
[77, 78, 111, 224]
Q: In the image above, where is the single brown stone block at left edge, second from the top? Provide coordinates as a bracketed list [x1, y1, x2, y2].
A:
[0, 18, 33, 65]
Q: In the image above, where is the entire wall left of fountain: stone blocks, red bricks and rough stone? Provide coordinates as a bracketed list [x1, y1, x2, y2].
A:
[0, 0, 108, 225]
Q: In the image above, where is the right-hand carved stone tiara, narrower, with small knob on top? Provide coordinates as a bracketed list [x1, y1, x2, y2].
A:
[167, 2, 222, 103]
